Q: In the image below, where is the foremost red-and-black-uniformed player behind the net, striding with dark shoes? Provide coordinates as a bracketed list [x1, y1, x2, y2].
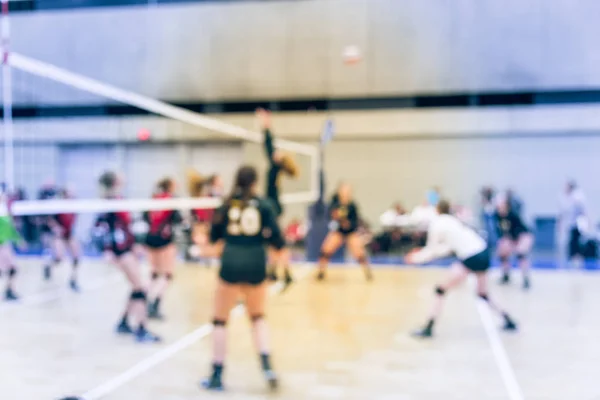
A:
[96, 172, 160, 342]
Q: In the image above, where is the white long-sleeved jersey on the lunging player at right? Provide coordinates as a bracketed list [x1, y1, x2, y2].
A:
[413, 214, 487, 264]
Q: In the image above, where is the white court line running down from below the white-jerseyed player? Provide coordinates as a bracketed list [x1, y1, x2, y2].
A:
[471, 281, 525, 400]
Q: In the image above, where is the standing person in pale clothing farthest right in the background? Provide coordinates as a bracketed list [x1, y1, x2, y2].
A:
[558, 180, 591, 263]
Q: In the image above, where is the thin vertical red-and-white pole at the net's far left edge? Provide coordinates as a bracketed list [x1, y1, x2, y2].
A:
[0, 0, 15, 191]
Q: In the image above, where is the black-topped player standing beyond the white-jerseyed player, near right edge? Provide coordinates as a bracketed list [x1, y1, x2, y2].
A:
[494, 201, 534, 289]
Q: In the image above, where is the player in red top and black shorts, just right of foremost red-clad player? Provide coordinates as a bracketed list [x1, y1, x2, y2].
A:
[144, 178, 183, 319]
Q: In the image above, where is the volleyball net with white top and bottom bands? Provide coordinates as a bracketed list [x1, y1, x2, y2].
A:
[0, 53, 319, 247]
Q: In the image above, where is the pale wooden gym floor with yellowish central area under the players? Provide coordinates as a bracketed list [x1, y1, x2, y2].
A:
[0, 259, 600, 400]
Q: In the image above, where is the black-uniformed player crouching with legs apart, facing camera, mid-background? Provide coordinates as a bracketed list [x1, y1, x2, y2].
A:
[317, 183, 373, 281]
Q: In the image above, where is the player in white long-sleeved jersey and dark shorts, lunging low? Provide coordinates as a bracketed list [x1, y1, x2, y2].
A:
[406, 200, 517, 337]
